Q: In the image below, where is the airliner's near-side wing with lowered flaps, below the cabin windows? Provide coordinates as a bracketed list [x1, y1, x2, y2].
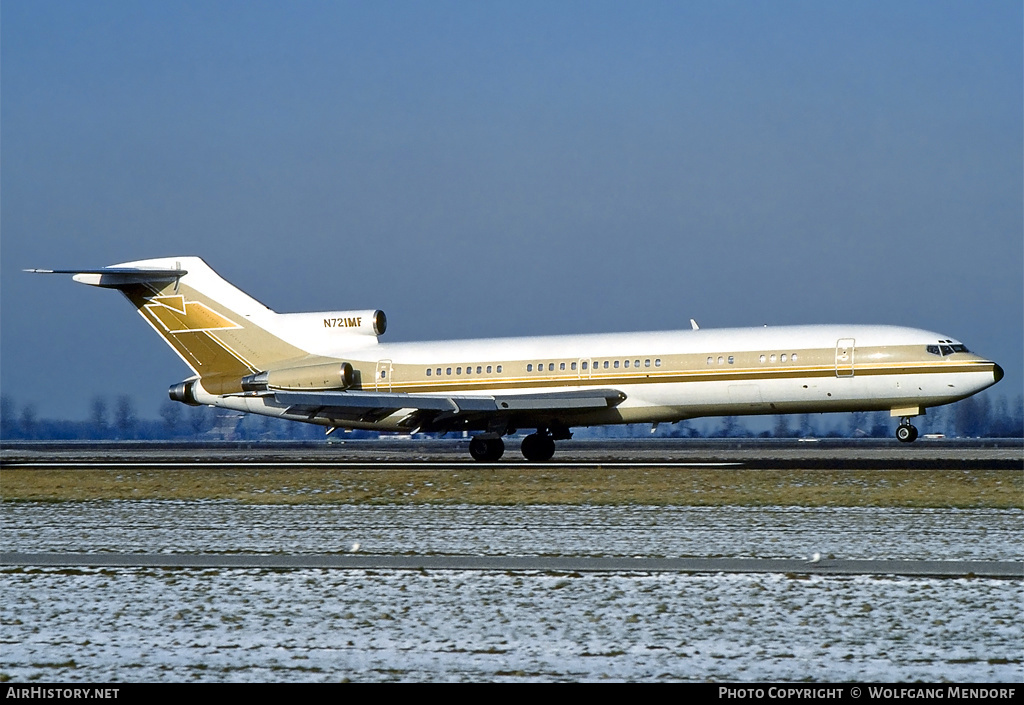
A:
[273, 389, 626, 430]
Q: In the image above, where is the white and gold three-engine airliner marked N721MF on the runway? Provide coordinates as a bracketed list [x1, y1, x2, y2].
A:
[31, 257, 1002, 461]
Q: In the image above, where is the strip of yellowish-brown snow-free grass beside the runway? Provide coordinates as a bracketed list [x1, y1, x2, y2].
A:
[0, 465, 1024, 508]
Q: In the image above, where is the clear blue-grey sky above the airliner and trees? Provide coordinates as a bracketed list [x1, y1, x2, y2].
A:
[0, 0, 1024, 418]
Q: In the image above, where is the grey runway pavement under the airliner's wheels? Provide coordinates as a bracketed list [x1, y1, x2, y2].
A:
[0, 437, 1024, 470]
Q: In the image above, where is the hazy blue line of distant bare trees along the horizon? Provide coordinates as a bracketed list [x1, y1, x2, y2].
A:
[0, 393, 1024, 441]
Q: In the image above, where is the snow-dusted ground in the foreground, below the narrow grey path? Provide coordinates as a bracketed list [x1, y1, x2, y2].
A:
[0, 569, 1024, 682]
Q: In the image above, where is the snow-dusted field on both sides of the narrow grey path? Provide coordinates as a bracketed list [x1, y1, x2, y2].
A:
[0, 502, 1024, 682]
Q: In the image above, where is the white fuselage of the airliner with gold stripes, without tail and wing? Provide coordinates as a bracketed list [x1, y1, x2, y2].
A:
[197, 325, 1001, 430]
